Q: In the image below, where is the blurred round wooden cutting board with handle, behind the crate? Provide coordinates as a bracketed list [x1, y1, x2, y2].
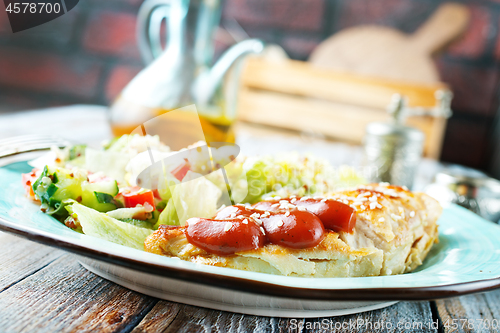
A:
[309, 3, 469, 83]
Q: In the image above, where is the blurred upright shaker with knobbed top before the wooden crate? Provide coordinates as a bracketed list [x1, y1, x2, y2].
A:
[363, 94, 425, 188]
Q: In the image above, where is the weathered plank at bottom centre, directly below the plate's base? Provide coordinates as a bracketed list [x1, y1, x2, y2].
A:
[133, 301, 437, 333]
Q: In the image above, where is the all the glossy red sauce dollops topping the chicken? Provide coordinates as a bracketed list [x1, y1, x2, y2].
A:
[185, 198, 356, 255]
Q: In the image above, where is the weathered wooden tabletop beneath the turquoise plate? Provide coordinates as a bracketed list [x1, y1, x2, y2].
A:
[0, 105, 500, 332]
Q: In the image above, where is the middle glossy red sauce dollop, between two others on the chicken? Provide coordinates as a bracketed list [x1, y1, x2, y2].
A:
[261, 210, 325, 249]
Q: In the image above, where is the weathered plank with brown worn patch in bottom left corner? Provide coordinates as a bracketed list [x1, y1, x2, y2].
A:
[0, 254, 157, 333]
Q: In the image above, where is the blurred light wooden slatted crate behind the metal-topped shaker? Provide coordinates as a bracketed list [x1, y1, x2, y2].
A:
[238, 57, 449, 159]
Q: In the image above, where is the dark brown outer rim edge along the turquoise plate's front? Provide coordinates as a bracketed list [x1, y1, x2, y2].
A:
[0, 158, 500, 301]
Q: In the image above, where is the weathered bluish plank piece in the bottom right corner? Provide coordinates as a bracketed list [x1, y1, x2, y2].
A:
[436, 290, 500, 332]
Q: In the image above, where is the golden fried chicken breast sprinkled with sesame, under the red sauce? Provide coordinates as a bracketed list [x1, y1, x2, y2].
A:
[144, 184, 441, 277]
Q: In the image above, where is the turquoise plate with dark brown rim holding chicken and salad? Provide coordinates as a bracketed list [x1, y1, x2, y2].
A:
[0, 162, 500, 301]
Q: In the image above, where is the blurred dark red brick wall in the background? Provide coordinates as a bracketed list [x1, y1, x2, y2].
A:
[0, 0, 500, 171]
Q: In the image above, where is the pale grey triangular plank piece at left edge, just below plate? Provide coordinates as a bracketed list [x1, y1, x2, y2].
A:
[0, 232, 64, 292]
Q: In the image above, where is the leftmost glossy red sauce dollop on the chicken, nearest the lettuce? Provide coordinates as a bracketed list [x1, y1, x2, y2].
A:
[185, 217, 265, 255]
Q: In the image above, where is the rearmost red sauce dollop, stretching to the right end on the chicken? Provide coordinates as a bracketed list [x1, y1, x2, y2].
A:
[252, 198, 356, 233]
